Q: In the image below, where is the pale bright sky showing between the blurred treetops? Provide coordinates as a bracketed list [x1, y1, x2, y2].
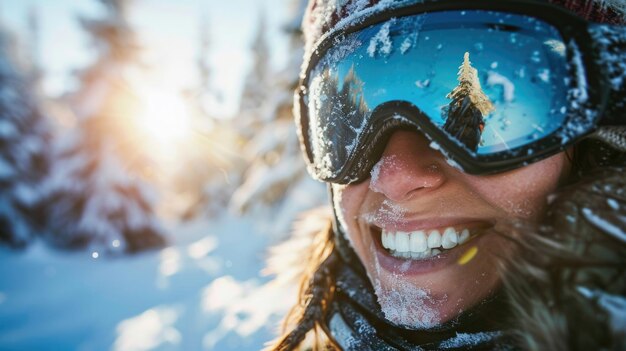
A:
[0, 0, 289, 114]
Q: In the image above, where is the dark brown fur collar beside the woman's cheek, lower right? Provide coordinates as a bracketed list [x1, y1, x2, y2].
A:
[504, 168, 626, 350]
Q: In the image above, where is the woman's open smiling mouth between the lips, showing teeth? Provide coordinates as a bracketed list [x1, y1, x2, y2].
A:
[372, 226, 485, 260]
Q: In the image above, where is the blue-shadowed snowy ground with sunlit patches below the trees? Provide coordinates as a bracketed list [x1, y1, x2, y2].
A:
[0, 215, 293, 351]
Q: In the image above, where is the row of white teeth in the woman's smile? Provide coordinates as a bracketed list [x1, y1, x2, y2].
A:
[381, 227, 470, 260]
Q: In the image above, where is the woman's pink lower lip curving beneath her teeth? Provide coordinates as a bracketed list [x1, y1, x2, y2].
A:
[374, 233, 491, 275]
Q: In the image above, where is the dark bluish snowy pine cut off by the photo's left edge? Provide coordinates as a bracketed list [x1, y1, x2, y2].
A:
[0, 28, 50, 247]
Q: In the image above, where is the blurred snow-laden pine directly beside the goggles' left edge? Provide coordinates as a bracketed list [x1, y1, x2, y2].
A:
[231, 0, 327, 239]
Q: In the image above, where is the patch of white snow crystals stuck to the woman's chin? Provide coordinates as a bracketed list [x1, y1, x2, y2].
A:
[374, 276, 441, 329]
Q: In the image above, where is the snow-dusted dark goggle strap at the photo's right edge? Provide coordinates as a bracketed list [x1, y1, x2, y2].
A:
[589, 24, 626, 126]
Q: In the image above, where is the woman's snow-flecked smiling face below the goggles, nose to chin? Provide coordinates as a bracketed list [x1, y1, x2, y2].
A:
[333, 131, 569, 328]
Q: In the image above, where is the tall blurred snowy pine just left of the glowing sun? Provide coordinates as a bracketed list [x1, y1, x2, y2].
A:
[44, 0, 165, 254]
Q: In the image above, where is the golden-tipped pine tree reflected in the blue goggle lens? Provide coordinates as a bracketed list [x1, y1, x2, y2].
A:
[443, 52, 495, 151]
